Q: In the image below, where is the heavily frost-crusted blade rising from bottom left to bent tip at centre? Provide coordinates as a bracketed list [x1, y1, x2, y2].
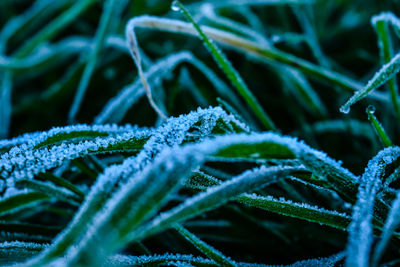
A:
[27, 108, 247, 266]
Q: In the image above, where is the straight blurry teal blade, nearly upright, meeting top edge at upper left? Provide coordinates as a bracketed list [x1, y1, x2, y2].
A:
[68, 0, 118, 121]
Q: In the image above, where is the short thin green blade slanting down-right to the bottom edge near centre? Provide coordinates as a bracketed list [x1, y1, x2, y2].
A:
[174, 224, 237, 266]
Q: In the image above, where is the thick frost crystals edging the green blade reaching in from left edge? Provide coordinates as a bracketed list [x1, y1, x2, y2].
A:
[0, 125, 151, 184]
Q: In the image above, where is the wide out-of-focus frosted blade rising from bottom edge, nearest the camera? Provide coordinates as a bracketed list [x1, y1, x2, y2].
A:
[68, 140, 209, 266]
